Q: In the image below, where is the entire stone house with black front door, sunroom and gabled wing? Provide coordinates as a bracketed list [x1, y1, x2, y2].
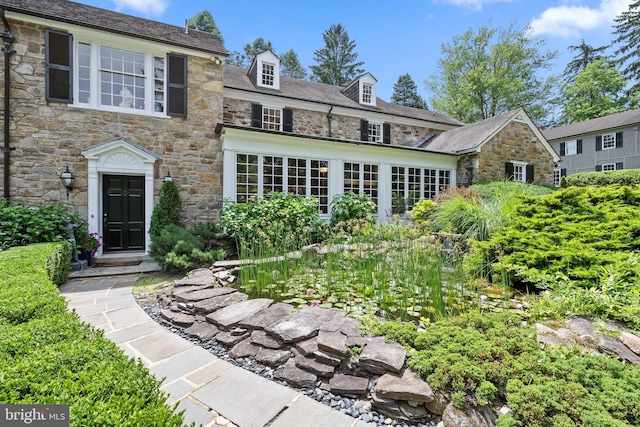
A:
[0, 0, 555, 258]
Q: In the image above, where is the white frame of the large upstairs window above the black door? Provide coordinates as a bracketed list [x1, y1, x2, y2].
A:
[70, 32, 169, 118]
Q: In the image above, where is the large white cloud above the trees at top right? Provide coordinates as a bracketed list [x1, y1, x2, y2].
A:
[531, 0, 633, 39]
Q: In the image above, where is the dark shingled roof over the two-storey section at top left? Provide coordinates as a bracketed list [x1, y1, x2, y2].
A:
[0, 0, 228, 56]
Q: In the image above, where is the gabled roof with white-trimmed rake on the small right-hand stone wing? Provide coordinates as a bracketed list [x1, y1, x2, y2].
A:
[422, 108, 559, 160]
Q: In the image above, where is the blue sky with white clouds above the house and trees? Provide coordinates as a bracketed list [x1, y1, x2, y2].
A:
[74, 0, 633, 101]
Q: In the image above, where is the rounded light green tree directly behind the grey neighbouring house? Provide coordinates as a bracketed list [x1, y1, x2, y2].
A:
[561, 58, 640, 124]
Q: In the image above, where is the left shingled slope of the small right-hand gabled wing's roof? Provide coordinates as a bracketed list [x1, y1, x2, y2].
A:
[423, 108, 523, 153]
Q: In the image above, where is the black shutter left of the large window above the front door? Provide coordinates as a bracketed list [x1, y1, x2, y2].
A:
[44, 29, 73, 102]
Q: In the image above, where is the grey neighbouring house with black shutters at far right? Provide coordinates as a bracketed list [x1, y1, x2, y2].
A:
[542, 109, 640, 183]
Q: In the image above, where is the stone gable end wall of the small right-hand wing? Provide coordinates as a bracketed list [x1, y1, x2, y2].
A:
[457, 121, 554, 185]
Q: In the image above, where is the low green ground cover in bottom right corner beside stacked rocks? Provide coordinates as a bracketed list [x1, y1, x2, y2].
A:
[368, 313, 640, 427]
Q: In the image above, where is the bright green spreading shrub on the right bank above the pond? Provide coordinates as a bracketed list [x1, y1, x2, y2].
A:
[476, 185, 640, 329]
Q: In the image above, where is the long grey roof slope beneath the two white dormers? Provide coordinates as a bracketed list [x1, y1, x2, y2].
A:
[222, 64, 464, 126]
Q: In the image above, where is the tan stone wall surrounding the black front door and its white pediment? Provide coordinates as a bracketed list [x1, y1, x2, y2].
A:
[0, 20, 222, 221]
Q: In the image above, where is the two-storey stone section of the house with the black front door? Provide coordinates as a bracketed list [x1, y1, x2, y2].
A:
[0, 0, 227, 251]
